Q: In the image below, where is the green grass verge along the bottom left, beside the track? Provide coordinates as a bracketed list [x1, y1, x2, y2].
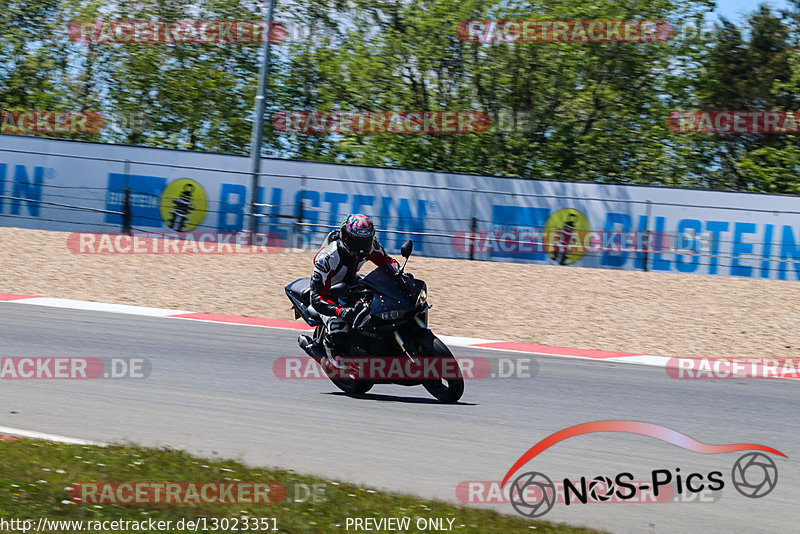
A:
[0, 440, 594, 534]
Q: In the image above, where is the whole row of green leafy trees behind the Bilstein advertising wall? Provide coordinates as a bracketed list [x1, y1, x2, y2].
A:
[0, 0, 800, 193]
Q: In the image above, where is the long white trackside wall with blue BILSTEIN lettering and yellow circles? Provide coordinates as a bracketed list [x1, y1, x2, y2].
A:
[0, 135, 800, 280]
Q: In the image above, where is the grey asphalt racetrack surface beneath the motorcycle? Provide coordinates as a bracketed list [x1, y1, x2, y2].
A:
[0, 303, 800, 533]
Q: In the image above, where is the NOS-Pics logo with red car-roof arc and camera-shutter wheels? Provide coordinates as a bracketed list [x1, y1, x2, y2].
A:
[500, 421, 787, 518]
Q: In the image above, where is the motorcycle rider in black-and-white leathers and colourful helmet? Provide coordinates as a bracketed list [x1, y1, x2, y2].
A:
[311, 214, 397, 365]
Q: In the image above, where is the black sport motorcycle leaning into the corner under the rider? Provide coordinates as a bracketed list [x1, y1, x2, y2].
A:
[286, 241, 464, 403]
